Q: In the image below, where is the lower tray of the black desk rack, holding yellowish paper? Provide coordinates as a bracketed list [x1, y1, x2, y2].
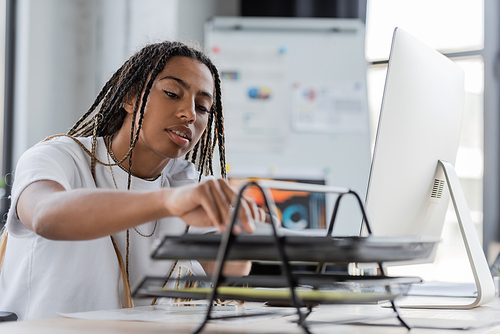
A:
[134, 272, 422, 304]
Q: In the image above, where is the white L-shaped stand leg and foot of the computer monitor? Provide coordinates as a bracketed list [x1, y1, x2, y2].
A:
[397, 160, 495, 309]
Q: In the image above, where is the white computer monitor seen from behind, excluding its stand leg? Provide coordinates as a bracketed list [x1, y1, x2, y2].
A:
[366, 28, 465, 263]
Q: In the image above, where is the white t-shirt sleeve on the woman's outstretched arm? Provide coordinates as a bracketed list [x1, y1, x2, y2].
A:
[7, 143, 79, 237]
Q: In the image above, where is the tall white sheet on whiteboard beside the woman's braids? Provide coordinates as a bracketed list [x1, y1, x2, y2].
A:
[212, 46, 289, 152]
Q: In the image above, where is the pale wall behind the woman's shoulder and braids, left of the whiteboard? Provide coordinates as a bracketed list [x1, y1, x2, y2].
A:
[13, 0, 179, 164]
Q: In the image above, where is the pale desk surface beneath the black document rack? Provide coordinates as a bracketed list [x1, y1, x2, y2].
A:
[0, 297, 500, 334]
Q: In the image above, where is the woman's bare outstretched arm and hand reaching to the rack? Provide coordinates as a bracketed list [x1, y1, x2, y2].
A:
[16, 179, 264, 240]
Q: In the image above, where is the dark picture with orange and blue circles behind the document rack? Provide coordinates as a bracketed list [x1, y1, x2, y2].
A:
[229, 178, 326, 230]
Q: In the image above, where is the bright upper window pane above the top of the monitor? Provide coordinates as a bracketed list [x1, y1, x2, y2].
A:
[366, 0, 484, 61]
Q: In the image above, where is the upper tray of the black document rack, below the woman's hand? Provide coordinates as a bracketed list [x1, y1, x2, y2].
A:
[152, 234, 439, 263]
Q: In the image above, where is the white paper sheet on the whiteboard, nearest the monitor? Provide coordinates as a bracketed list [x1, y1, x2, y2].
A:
[292, 82, 368, 133]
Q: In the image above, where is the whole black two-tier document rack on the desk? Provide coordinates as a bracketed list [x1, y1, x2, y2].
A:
[134, 181, 430, 334]
